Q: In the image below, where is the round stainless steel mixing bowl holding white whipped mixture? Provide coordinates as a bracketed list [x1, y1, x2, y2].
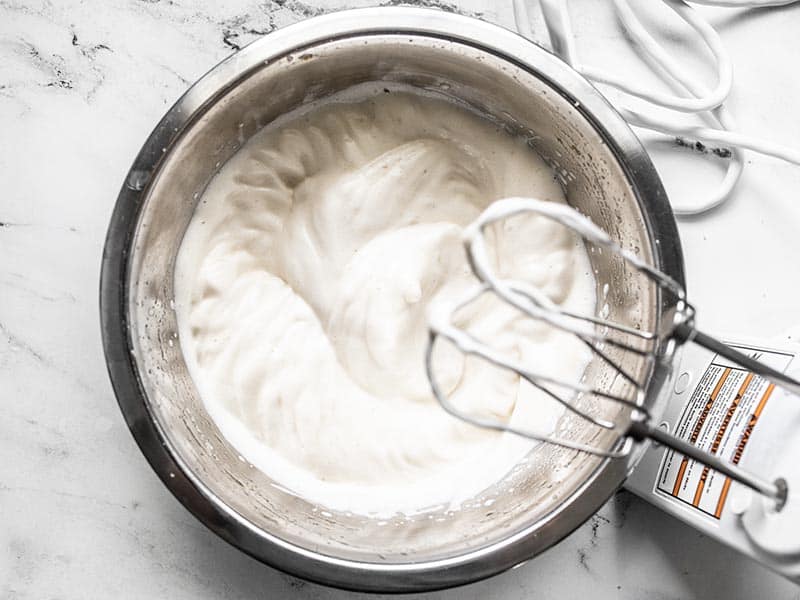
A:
[100, 8, 684, 592]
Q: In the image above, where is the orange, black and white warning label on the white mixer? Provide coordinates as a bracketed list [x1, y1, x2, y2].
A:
[657, 346, 793, 519]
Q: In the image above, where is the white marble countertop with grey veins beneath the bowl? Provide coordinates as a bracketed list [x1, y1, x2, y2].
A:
[0, 0, 800, 600]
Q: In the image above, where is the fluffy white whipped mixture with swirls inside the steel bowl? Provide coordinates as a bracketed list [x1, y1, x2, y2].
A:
[175, 91, 595, 514]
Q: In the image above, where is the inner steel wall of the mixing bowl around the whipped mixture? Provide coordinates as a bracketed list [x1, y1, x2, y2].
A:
[127, 34, 660, 564]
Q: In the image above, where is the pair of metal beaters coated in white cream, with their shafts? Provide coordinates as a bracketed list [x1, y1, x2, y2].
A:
[425, 198, 800, 508]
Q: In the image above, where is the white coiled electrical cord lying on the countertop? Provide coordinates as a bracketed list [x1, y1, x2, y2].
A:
[514, 0, 800, 216]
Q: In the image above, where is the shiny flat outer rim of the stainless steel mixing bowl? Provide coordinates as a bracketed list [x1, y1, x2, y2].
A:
[100, 7, 685, 592]
